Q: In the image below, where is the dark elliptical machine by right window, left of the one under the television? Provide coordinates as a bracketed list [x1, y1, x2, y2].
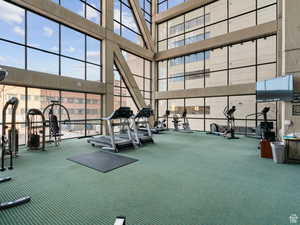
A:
[207, 106, 239, 139]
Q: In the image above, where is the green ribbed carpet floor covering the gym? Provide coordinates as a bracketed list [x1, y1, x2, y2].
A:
[0, 132, 300, 225]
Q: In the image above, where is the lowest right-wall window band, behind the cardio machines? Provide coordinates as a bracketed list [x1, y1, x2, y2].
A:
[158, 95, 277, 134]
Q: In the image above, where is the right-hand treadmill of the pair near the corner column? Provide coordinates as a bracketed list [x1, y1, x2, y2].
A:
[120, 107, 154, 145]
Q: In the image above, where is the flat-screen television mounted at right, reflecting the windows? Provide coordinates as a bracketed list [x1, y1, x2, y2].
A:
[256, 75, 294, 102]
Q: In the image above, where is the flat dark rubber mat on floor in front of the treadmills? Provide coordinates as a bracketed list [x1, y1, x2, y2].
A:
[68, 151, 138, 173]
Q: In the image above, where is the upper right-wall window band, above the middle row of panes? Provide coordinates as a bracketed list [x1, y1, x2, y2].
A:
[157, 0, 277, 51]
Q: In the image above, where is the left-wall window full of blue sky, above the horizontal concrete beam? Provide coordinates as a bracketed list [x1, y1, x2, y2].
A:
[0, 0, 102, 82]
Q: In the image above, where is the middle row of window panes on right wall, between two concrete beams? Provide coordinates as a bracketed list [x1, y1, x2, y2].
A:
[158, 36, 276, 91]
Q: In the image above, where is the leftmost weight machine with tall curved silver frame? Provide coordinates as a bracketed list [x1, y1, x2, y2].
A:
[0, 97, 19, 171]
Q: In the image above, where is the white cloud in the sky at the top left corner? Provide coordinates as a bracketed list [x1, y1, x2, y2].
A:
[0, 0, 24, 24]
